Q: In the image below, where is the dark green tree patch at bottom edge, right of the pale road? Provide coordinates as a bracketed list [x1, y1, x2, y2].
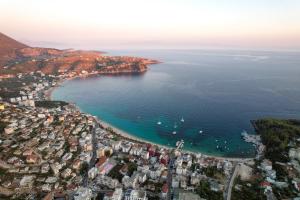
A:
[231, 177, 266, 200]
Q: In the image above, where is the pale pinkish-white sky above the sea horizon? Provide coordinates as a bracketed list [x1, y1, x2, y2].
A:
[0, 0, 300, 50]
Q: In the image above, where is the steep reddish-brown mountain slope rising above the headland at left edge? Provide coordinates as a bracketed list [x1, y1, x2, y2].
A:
[0, 32, 28, 57]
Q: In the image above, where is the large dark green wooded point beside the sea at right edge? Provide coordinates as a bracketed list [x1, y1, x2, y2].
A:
[253, 119, 300, 162]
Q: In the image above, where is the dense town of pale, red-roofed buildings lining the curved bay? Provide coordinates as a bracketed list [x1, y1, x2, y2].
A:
[0, 69, 300, 200]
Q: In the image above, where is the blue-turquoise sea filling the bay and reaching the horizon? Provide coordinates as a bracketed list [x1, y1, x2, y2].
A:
[52, 50, 300, 157]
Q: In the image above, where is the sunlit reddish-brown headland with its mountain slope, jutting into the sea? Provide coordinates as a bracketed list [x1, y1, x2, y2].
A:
[0, 33, 157, 77]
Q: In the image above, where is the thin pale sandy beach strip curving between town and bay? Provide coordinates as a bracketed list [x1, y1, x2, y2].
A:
[43, 74, 255, 162]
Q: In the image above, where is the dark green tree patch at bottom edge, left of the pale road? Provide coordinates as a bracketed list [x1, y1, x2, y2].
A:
[196, 180, 223, 200]
